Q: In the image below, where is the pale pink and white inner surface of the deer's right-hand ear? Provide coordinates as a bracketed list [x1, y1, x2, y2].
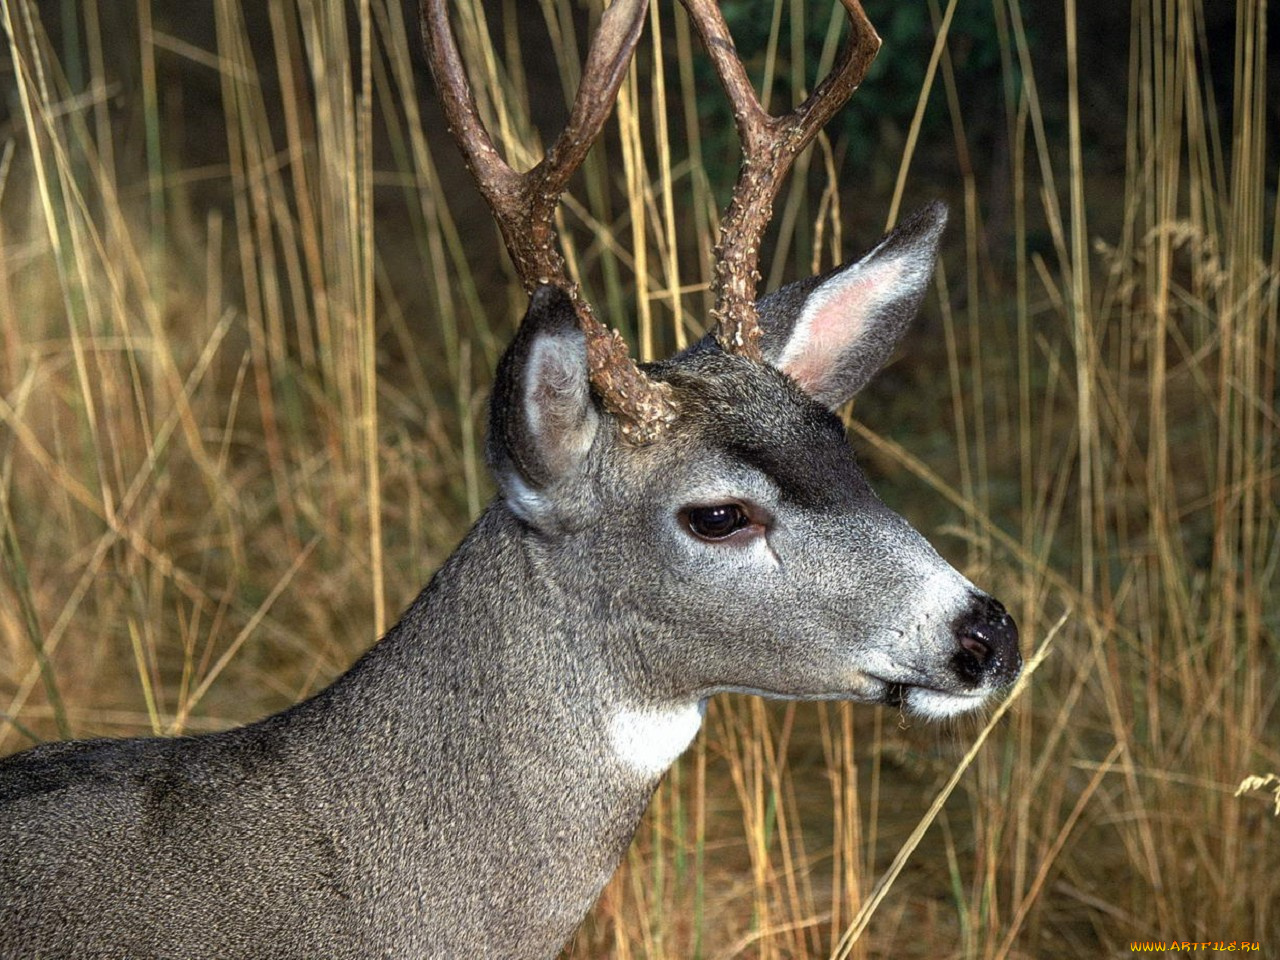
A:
[780, 261, 902, 394]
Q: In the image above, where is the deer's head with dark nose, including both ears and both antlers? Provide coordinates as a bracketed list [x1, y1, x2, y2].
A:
[422, 0, 1020, 716]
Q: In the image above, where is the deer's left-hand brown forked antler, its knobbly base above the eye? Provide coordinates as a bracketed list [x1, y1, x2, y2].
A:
[421, 0, 675, 443]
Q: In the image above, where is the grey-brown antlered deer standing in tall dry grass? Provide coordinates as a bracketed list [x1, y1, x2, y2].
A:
[0, 0, 1021, 960]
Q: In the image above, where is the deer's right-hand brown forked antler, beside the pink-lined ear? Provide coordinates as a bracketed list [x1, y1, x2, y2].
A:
[681, 0, 881, 360]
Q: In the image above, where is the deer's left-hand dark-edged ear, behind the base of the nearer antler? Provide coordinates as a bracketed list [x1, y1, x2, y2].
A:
[486, 285, 599, 524]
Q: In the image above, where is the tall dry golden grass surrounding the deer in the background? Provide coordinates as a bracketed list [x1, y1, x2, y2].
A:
[0, 0, 1280, 957]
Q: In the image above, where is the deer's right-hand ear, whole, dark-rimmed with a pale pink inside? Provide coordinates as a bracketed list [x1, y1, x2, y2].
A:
[758, 201, 947, 410]
